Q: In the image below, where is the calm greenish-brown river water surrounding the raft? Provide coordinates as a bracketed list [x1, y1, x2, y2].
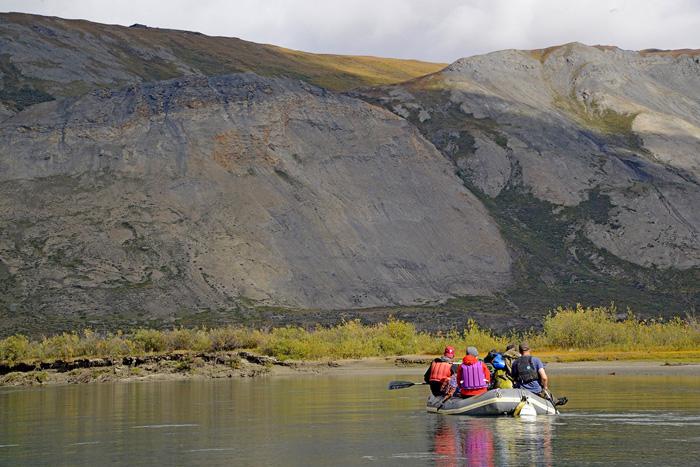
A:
[0, 370, 700, 466]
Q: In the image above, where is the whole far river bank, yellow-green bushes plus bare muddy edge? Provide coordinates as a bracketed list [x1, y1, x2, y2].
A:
[0, 306, 700, 386]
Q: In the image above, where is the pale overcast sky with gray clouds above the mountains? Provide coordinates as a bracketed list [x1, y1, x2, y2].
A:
[0, 0, 700, 62]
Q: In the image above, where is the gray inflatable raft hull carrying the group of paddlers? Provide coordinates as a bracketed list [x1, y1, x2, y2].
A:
[427, 389, 559, 415]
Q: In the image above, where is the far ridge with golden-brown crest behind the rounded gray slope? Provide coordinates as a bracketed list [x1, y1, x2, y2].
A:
[0, 13, 444, 112]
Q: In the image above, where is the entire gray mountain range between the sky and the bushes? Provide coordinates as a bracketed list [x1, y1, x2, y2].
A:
[0, 14, 700, 334]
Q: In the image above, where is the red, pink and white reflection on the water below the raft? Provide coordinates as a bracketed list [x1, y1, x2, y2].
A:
[432, 416, 556, 467]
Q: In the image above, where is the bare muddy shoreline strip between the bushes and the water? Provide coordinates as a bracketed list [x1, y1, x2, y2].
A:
[0, 351, 700, 387]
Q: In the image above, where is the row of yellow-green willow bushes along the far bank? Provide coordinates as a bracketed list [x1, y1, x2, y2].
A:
[0, 305, 700, 364]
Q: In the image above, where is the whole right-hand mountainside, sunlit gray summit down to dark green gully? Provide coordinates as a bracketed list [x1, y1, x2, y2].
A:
[362, 44, 700, 312]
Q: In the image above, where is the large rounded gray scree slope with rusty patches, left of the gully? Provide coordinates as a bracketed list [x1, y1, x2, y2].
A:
[0, 74, 510, 332]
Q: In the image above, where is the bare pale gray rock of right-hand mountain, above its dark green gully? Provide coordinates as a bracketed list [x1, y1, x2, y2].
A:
[366, 44, 700, 269]
